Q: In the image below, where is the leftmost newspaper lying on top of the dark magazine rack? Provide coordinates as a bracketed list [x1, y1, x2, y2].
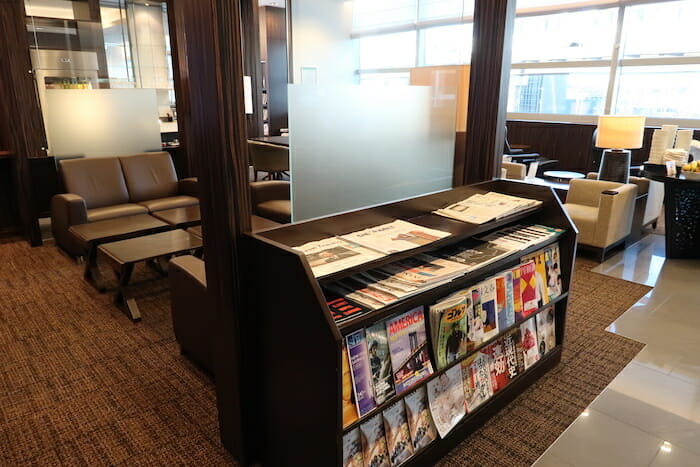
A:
[294, 237, 384, 277]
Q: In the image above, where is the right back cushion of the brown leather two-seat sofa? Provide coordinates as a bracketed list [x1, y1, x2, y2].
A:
[119, 152, 178, 203]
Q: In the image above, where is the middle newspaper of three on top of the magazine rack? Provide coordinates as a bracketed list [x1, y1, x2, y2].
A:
[341, 220, 450, 255]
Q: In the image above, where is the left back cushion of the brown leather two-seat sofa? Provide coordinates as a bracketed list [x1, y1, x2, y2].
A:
[60, 157, 129, 209]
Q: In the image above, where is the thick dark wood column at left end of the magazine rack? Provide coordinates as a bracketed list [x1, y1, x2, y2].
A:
[168, 0, 250, 460]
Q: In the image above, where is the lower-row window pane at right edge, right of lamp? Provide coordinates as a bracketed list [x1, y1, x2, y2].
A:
[615, 65, 700, 118]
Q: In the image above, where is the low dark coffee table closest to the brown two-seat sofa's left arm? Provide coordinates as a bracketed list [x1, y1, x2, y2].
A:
[68, 214, 172, 292]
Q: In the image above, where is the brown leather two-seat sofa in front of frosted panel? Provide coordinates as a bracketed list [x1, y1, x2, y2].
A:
[51, 152, 199, 256]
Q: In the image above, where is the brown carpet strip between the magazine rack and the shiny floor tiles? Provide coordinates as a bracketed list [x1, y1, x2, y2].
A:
[438, 258, 651, 467]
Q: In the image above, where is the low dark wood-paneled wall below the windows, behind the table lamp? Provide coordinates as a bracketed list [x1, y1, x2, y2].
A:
[507, 120, 700, 173]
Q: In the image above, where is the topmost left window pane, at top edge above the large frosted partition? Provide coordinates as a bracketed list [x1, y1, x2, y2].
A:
[352, 0, 417, 32]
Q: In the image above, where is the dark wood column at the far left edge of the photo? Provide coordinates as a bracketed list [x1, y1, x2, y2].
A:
[0, 0, 46, 246]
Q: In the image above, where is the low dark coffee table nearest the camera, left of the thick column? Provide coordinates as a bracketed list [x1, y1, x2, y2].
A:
[98, 229, 202, 321]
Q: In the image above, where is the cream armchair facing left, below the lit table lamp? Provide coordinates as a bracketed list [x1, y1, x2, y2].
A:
[564, 179, 637, 261]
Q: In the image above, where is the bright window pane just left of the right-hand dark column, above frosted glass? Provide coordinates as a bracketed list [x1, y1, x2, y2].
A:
[422, 23, 473, 66]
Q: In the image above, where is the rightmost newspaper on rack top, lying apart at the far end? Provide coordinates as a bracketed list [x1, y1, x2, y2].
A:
[433, 191, 542, 224]
